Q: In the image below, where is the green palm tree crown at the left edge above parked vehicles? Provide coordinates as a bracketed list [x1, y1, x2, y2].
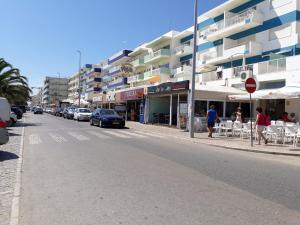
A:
[0, 58, 31, 104]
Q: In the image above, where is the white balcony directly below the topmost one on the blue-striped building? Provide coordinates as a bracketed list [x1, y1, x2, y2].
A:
[202, 41, 262, 64]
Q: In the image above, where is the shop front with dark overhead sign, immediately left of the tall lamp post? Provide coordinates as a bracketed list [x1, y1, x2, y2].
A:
[145, 81, 189, 128]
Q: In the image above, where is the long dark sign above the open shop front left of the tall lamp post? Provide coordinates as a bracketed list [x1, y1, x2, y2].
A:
[148, 80, 189, 94]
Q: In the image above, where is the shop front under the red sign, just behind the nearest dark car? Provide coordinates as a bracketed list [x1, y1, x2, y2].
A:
[120, 88, 145, 123]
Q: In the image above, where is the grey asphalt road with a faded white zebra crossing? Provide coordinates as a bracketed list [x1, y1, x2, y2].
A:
[20, 114, 300, 225]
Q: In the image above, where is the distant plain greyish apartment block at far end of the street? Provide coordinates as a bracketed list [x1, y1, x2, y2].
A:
[43, 77, 68, 105]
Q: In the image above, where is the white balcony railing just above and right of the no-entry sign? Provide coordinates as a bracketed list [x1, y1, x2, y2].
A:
[258, 58, 286, 74]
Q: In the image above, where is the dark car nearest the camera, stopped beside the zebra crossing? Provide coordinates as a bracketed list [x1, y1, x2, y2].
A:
[90, 109, 125, 128]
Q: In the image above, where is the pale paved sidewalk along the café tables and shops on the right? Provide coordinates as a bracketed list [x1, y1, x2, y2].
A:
[126, 121, 300, 157]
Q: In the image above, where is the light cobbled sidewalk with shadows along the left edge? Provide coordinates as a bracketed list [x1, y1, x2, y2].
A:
[0, 121, 22, 225]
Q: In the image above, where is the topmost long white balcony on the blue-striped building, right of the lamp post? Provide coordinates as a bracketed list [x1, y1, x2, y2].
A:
[203, 9, 263, 41]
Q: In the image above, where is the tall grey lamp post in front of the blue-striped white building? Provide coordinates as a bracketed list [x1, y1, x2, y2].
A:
[190, 0, 198, 138]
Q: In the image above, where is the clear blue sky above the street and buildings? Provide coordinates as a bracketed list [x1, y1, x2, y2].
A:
[0, 0, 226, 91]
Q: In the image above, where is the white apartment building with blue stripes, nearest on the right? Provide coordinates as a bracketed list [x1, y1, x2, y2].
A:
[166, 0, 300, 122]
